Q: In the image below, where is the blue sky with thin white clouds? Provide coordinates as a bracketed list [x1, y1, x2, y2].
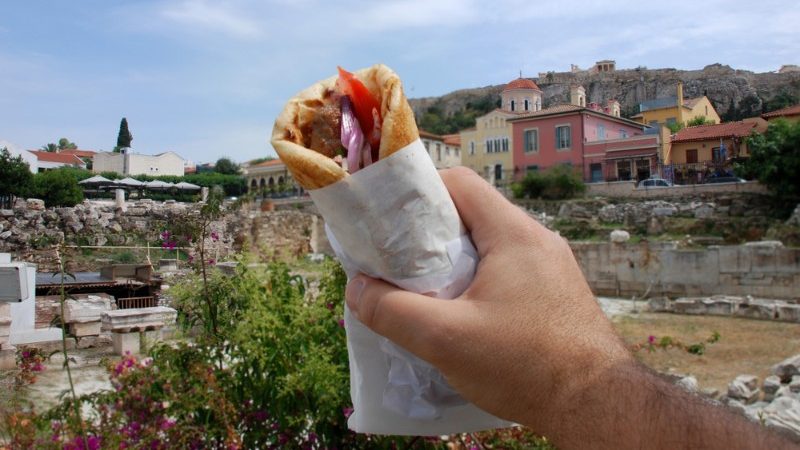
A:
[0, 0, 800, 163]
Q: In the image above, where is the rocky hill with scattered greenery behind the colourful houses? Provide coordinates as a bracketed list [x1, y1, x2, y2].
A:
[410, 64, 800, 133]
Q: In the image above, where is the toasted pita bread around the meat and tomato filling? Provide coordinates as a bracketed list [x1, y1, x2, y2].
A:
[271, 64, 419, 189]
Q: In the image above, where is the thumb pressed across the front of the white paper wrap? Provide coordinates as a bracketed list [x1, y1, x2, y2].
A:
[345, 275, 452, 362]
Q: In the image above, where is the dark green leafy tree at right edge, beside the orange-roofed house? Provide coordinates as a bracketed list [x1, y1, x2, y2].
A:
[739, 119, 800, 205]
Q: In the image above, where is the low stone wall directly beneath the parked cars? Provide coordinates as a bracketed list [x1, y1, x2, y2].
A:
[586, 181, 767, 198]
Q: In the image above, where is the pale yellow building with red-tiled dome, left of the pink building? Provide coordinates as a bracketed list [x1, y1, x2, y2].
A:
[459, 78, 542, 187]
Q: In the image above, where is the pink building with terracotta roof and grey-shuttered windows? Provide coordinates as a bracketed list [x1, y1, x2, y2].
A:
[508, 103, 658, 181]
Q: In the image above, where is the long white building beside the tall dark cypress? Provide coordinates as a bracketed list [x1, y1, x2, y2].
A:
[92, 149, 185, 176]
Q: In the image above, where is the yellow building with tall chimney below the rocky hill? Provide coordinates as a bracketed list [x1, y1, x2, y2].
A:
[631, 82, 720, 127]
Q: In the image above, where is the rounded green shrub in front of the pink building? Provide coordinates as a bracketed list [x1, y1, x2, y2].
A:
[511, 165, 586, 200]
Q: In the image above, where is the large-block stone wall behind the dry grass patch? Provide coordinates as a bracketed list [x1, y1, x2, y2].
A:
[570, 242, 800, 299]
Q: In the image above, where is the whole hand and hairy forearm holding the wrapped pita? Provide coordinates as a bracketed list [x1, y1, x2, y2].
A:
[346, 167, 791, 449]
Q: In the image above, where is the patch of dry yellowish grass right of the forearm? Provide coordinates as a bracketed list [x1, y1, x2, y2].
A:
[614, 313, 800, 392]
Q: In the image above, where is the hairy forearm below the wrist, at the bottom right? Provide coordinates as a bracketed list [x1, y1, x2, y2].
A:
[537, 363, 796, 449]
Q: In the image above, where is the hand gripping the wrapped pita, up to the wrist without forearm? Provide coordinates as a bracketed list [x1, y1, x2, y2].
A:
[347, 168, 631, 431]
